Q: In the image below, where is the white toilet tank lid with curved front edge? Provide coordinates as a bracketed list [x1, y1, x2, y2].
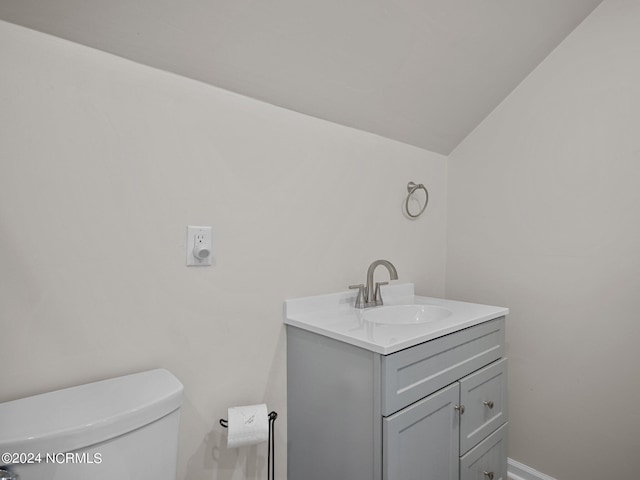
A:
[0, 369, 184, 455]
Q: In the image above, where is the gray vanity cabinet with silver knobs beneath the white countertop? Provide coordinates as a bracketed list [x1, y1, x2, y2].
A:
[287, 317, 507, 480]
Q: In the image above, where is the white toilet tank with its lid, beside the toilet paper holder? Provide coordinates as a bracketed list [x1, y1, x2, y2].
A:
[0, 369, 183, 480]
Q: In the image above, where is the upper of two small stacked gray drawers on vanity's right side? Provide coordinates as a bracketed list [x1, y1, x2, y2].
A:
[460, 358, 507, 454]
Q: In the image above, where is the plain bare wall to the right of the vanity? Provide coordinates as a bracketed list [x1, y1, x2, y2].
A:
[447, 0, 640, 480]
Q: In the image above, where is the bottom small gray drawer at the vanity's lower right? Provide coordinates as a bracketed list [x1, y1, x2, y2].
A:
[460, 423, 507, 480]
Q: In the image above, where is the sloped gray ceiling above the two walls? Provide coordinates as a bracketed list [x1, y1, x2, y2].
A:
[0, 0, 602, 154]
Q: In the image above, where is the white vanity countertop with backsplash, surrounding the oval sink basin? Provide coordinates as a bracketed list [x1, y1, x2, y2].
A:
[284, 283, 509, 355]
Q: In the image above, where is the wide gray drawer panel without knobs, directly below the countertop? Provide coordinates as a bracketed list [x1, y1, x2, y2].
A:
[381, 317, 504, 416]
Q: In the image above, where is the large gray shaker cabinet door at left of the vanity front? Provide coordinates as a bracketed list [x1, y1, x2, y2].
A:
[382, 383, 460, 480]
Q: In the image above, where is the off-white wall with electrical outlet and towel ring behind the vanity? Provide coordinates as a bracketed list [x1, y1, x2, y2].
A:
[0, 22, 446, 480]
